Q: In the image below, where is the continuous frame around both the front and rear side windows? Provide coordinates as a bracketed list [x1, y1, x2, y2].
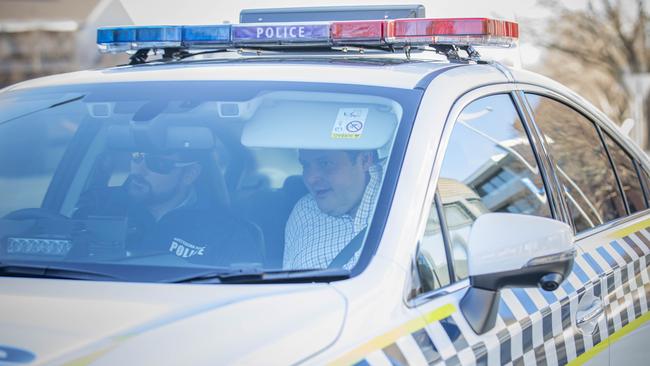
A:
[404, 83, 650, 307]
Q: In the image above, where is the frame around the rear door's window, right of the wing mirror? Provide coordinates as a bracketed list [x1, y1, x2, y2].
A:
[519, 84, 650, 242]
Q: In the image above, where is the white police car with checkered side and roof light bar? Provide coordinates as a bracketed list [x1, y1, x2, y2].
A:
[0, 7, 650, 365]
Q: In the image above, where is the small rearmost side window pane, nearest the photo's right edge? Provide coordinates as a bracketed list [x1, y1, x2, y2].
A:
[603, 133, 648, 213]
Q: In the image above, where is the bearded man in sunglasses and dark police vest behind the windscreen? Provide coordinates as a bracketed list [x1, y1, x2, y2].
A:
[75, 151, 263, 266]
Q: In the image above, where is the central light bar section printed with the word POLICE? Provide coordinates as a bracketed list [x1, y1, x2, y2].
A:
[231, 22, 330, 45]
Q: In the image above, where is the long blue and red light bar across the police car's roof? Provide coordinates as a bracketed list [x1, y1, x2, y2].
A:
[97, 18, 519, 53]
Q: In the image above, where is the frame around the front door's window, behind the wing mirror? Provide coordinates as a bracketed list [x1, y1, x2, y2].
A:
[404, 83, 566, 307]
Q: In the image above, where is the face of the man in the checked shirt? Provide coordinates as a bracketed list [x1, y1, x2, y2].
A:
[299, 150, 372, 216]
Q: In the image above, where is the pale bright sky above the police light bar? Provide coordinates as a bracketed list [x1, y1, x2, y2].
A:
[121, 0, 587, 67]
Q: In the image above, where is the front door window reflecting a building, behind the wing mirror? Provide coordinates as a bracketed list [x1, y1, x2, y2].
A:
[432, 94, 551, 279]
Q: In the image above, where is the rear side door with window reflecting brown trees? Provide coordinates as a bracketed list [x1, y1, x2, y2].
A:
[526, 90, 650, 365]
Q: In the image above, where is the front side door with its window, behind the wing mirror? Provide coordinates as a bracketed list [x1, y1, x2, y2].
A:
[411, 86, 609, 365]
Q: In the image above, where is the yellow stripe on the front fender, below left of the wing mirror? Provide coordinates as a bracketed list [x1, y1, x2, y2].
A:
[330, 304, 456, 365]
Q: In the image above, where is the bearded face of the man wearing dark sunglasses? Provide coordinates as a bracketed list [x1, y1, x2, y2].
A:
[126, 153, 195, 206]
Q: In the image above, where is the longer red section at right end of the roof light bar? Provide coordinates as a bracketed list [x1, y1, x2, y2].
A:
[386, 18, 519, 47]
